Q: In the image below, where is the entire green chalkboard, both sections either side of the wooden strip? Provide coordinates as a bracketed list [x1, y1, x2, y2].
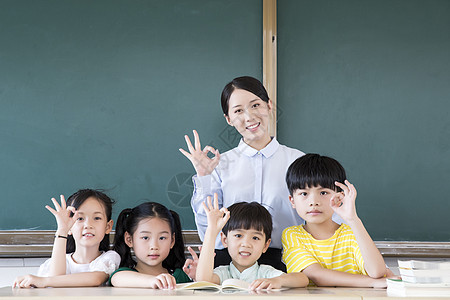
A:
[0, 0, 450, 241]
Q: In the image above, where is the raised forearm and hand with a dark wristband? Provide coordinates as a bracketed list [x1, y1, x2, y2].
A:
[45, 195, 77, 276]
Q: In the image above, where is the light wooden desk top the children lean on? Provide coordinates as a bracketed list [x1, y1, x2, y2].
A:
[0, 287, 450, 300]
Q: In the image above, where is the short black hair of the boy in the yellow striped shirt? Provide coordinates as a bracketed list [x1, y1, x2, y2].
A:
[286, 153, 347, 195]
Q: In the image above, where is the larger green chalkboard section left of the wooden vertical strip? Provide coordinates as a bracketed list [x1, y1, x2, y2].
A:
[0, 0, 262, 230]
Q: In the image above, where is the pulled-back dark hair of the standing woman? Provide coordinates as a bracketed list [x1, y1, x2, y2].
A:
[220, 76, 269, 116]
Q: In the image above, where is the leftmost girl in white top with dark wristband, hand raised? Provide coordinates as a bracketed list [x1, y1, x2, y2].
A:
[13, 189, 120, 288]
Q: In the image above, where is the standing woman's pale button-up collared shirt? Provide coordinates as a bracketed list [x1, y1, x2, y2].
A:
[191, 138, 304, 249]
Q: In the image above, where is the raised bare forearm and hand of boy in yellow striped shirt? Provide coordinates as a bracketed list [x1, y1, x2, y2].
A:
[330, 180, 386, 278]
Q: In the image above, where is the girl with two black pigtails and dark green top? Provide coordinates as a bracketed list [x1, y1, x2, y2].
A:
[110, 202, 191, 289]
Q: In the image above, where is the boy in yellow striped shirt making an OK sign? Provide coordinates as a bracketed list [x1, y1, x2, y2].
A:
[282, 154, 387, 287]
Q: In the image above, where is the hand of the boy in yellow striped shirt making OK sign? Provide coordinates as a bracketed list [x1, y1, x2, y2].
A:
[330, 180, 358, 223]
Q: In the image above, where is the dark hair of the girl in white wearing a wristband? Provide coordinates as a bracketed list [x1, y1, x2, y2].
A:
[66, 189, 114, 253]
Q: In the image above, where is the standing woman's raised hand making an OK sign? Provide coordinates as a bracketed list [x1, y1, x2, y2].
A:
[179, 130, 220, 176]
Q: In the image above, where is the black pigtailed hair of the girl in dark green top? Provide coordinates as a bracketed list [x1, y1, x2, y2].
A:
[114, 202, 186, 273]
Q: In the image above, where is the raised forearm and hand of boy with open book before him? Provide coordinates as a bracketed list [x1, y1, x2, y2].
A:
[196, 194, 230, 284]
